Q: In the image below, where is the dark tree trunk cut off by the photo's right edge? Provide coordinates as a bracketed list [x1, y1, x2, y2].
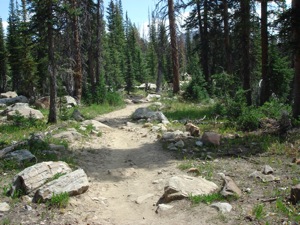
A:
[292, 0, 300, 119]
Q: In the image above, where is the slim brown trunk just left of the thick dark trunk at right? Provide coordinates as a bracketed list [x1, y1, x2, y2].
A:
[223, 0, 232, 74]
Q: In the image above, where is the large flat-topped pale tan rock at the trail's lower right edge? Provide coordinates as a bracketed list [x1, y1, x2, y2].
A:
[159, 176, 218, 203]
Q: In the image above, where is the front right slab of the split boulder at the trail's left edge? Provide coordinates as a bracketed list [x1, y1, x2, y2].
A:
[32, 169, 89, 202]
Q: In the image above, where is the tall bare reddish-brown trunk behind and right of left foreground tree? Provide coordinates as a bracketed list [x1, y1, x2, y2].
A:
[71, 0, 82, 103]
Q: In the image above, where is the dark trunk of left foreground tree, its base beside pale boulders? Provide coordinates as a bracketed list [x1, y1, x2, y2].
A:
[47, 0, 57, 123]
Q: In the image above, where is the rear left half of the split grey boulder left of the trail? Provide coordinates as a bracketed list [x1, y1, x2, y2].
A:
[9, 161, 72, 196]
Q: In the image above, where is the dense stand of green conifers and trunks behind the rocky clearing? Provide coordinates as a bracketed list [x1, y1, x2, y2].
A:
[0, 0, 300, 122]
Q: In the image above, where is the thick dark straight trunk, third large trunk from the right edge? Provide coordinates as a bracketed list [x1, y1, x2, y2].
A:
[241, 0, 252, 105]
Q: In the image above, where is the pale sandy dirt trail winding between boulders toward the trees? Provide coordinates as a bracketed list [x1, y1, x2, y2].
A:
[56, 104, 221, 225]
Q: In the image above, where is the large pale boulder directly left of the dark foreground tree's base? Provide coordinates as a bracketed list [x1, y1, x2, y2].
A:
[3, 103, 44, 120]
